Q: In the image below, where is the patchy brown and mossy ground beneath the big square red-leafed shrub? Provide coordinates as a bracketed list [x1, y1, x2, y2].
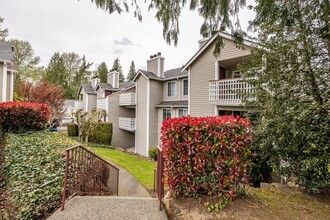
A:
[166, 184, 330, 220]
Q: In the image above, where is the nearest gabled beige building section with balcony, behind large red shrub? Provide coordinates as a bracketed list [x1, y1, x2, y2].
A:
[182, 32, 254, 116]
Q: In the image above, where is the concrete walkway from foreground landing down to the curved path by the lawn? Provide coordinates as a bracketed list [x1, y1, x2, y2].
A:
[48, 163, 167, 220]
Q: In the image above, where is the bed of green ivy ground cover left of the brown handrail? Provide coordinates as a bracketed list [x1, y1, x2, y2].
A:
[1, 131, 76, 219]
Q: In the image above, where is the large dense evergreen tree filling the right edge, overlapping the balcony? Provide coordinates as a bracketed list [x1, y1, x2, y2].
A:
[241, 0, 330, 192]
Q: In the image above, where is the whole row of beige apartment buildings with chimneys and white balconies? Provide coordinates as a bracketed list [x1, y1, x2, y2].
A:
[76, 32, 253, 156]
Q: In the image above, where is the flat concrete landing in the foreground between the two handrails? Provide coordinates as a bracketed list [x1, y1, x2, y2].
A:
[48, 196, 167, 220]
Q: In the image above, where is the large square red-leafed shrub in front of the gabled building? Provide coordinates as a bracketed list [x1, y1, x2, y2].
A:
[161, 116, 253, 202]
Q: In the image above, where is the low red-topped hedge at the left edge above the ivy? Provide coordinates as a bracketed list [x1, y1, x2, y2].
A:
[0, 102, 50, 133]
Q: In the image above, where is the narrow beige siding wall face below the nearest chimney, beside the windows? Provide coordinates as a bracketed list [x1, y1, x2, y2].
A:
[149, 80, 163, 149]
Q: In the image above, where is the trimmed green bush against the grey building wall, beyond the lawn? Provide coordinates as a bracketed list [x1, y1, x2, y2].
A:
[88, 122, 112, 144]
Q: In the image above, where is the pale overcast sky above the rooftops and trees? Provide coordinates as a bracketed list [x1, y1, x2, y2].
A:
[0, 0, 253, 75]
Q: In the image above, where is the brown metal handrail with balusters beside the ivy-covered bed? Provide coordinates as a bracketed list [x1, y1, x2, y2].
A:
[61, 145, 119, 210]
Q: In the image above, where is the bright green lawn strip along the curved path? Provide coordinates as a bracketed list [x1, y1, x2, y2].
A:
[93, 147, 156, 189]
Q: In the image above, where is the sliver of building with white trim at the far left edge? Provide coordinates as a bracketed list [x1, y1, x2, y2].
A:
[0, 41, 16, 102]
